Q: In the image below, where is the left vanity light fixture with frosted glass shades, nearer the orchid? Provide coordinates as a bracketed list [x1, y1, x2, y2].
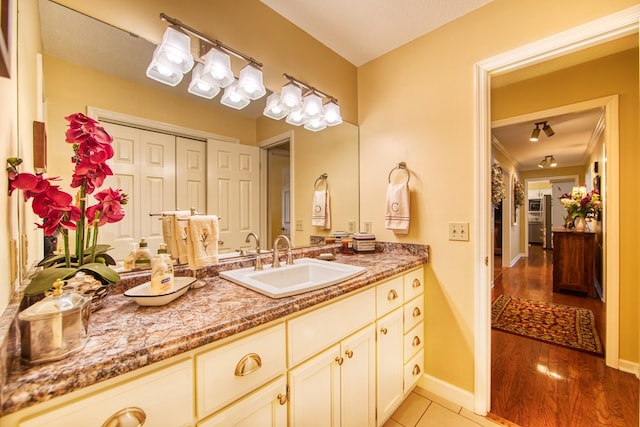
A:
[147, 13, 267, 109]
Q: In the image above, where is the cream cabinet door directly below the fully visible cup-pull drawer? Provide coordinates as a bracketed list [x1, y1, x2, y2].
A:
[198, 377, 287, 427]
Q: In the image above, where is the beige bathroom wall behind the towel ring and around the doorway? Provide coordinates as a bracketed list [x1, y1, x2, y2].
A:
[358, 0, 638, 392]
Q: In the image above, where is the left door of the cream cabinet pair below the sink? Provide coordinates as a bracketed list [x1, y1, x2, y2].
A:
[289, 344, 341, 427]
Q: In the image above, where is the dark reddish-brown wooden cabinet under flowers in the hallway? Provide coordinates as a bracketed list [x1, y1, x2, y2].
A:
[553, 228, 597, 298]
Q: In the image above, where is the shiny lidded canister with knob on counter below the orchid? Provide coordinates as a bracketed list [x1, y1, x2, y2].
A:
[18, 279, 91, 363]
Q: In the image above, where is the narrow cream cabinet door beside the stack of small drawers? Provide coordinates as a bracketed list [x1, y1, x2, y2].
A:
[377, 308, 404, 426]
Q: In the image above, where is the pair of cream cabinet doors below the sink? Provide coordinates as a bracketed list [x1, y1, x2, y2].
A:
[289, 325, 375, 427]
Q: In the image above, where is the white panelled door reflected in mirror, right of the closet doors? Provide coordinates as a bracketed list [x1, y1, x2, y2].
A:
[207, 140, 260, 253]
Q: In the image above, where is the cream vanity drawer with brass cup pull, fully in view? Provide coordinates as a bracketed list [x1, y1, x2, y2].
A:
[196, 323, 286, 419]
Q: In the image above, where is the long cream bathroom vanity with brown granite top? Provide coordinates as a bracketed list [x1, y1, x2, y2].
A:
[0, 245, 428, 427]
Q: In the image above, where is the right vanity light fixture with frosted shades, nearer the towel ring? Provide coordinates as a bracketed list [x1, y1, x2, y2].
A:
[264, 73, 342, 132]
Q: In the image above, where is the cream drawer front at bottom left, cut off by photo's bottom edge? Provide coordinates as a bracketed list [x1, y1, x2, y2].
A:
[18, 360, 194, 427]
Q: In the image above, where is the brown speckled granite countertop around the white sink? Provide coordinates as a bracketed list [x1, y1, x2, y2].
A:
[1, 246, 428, 415]
